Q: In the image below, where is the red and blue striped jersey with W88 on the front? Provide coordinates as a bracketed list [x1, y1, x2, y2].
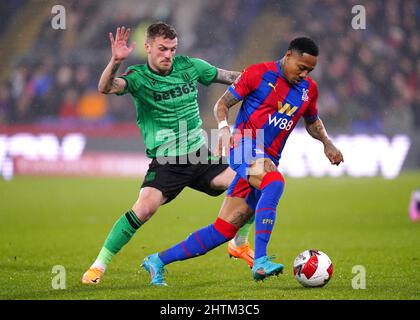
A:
[229, 61, 318, 163]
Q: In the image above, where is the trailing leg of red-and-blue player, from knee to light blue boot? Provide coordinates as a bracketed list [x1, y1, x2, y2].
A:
[142, 197, 253, 285]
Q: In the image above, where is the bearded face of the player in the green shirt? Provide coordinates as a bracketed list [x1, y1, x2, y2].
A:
[145, 37, 178, 74]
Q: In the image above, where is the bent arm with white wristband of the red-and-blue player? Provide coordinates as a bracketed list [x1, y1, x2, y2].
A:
[214, 90, 239, 156]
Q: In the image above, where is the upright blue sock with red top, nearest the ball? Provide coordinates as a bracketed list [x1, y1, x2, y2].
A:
[254, 172, 284, 260]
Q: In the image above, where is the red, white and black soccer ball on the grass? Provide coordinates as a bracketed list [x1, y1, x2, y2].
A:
[293, 250, 333, 287]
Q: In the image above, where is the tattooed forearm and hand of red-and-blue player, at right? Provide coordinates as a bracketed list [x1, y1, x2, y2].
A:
[305, 118, 344, 166]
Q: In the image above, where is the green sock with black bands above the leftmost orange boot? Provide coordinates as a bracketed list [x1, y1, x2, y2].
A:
[95, 210, 143, 269]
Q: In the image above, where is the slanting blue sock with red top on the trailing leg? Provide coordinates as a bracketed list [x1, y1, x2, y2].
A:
[159, 218, 238, 265]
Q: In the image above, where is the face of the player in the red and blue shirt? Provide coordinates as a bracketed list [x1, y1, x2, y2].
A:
[284, 50, 317, 84]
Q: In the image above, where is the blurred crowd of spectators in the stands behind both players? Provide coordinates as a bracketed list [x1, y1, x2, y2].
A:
[0, 0, 420, 133]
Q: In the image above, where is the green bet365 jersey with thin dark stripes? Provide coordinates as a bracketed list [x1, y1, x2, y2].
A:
[119, 56, 217, 158]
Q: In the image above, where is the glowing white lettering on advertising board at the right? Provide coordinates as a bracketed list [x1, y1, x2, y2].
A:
[279, 129, 411, 179]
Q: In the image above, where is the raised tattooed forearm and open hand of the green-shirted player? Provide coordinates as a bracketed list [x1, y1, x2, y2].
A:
[98, 27, 135, 94]
